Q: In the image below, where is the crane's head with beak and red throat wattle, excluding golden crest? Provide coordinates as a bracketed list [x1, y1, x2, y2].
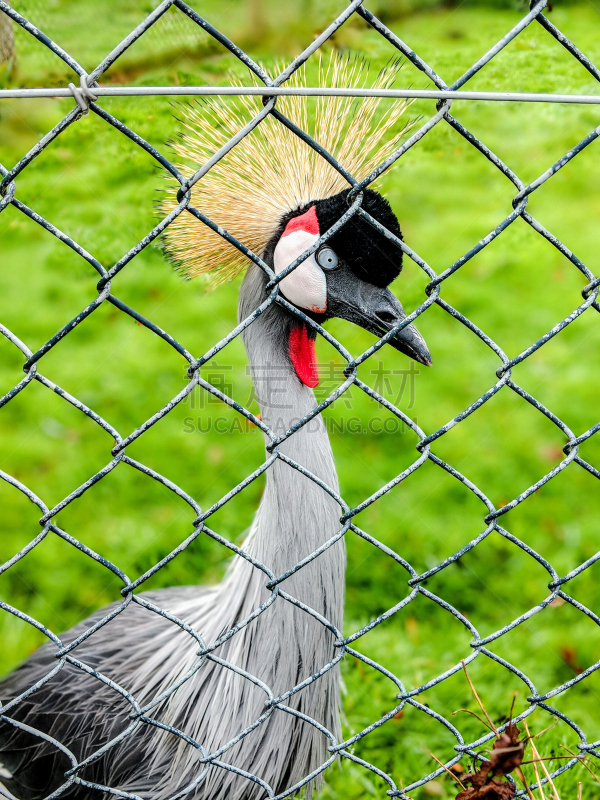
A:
[265, 189, 432, 386]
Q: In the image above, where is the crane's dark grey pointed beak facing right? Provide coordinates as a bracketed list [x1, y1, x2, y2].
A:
[327, 268, 432, 367]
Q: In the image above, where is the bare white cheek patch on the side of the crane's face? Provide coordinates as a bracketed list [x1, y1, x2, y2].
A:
[273, 230, 327, 313]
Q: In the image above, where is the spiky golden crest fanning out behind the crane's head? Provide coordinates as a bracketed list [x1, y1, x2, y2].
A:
[160, 54, 413, 287]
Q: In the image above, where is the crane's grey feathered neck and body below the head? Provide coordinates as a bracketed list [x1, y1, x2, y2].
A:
[0, 267, 345, 800]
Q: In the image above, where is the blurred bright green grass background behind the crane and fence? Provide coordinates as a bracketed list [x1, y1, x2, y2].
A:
[0, 0, 600, 800]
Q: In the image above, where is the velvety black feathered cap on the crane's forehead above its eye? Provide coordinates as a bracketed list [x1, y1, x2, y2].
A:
[316, 189, 402, 287]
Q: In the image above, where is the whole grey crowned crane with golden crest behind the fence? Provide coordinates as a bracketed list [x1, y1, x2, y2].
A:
[0, 57, 431, 800]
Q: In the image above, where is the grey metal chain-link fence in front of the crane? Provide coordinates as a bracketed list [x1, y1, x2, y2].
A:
[0, 0, 600, 798]
